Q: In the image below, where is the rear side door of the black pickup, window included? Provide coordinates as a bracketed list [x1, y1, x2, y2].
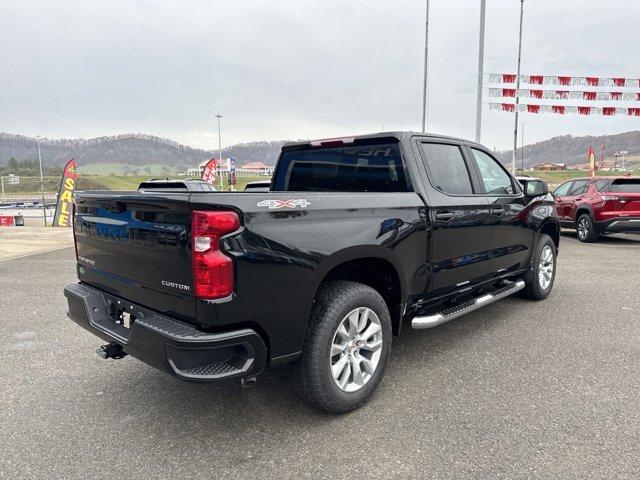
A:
[416, 137, 491, 298]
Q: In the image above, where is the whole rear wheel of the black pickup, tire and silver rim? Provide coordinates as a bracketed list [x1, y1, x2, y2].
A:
[301, 281, 392, 413]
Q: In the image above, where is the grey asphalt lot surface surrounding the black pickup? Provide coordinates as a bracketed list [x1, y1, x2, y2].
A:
[0, 233, 640, 478]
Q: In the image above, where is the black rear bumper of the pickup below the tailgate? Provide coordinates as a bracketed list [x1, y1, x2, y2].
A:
[64, 283, 267, 382]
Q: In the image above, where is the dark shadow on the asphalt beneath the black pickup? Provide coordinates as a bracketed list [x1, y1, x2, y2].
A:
[90, 299, 519, 432]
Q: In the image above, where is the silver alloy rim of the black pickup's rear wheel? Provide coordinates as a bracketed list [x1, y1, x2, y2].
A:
[329, 307, 382, 392]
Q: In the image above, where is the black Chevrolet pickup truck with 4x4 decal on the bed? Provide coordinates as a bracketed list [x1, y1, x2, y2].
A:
[64, 132, 559, 412]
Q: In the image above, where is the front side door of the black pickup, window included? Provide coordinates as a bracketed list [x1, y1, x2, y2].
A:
[469, 147, 534, 275]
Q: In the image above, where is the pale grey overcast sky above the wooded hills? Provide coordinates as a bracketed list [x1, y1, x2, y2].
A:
[0, 0, 640, 149]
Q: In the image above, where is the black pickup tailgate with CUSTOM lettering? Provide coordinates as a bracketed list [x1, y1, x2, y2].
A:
[74, 192, 195, 319]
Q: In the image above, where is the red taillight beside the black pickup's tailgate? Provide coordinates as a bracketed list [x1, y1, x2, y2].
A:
[191, 211, 240, 300]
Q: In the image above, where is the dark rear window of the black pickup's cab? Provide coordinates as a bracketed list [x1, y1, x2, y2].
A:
[272, 138, 412, 192]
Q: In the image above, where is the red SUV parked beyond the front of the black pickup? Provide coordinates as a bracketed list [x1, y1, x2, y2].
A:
[553, 176, 640, 242]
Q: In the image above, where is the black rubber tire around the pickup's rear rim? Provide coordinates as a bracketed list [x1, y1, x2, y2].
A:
[300, 281, 392, 413]
